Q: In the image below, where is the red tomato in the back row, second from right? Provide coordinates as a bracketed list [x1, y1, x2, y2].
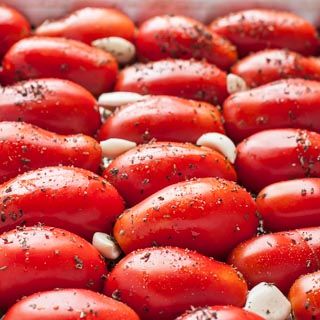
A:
[136, 15, 237, 69]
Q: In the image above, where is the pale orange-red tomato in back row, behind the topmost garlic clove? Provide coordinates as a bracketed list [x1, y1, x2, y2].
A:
[35, 7, 135, 45]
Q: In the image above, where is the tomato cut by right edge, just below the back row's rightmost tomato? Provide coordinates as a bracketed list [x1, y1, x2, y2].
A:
[231, 49, 320, 88]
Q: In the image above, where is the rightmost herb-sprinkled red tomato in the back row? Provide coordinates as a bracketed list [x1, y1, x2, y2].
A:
[210, 9, 318, 56]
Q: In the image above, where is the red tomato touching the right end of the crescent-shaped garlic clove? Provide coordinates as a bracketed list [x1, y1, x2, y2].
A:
[235, 129, 320, 192]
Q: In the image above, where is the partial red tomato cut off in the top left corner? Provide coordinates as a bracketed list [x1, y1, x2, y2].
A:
[0, 5, 30, 60]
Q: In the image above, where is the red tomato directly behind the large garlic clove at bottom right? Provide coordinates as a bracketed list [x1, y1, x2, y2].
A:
[228, 227, 320, 293]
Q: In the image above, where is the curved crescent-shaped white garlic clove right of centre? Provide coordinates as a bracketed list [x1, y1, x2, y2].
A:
[197, 132, 237, 163]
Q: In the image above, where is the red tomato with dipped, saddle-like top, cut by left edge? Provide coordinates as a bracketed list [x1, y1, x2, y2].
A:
[0, 121, 101, 182]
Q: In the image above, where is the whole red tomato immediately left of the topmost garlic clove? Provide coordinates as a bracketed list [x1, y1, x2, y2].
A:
[1, 37, 118, 95]
